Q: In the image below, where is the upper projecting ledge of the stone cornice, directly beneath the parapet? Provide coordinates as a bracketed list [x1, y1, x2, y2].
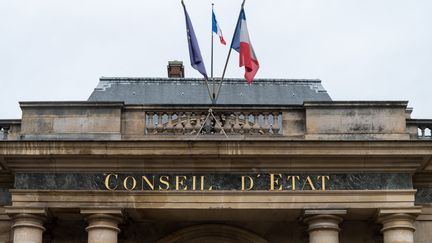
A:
[0, 139, 432, 157]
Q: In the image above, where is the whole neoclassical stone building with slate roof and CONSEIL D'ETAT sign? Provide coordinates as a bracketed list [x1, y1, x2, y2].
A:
[0, 63, 432, 243]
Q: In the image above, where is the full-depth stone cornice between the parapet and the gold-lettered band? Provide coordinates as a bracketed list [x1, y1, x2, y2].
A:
[0, 140, 432, 174]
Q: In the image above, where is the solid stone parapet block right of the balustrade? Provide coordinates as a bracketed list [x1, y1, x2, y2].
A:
[304, 101, 409, 140]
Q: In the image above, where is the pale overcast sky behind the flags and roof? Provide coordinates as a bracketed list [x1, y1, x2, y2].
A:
[0, 0, 432, 119]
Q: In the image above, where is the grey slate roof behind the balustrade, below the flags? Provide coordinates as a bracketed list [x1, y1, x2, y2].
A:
[88, 77, 331, 105]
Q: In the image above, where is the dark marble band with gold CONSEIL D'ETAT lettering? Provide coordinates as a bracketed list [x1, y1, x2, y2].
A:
[15, 172, 413, 192]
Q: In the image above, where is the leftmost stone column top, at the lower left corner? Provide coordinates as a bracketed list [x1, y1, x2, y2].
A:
[6, 208, 47, 243]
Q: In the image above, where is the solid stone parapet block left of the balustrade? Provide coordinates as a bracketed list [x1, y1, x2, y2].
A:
[21, 102, 122, 140]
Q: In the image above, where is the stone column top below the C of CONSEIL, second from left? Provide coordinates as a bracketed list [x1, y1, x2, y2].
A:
[81, 209, 123, 243]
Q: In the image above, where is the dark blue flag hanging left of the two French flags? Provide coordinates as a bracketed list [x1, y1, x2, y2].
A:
[182, 1, 207, 79]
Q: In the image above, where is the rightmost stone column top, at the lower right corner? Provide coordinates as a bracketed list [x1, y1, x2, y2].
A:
[378, 208, 421, 243]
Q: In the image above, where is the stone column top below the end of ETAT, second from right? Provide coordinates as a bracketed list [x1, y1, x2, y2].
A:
[304, 210, 346, 243]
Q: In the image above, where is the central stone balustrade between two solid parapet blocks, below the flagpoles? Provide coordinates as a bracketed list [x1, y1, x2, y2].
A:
[145, 110, 282, 136]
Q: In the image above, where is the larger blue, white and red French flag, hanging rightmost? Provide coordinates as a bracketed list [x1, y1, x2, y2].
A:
[231, 6, 259, 84]
